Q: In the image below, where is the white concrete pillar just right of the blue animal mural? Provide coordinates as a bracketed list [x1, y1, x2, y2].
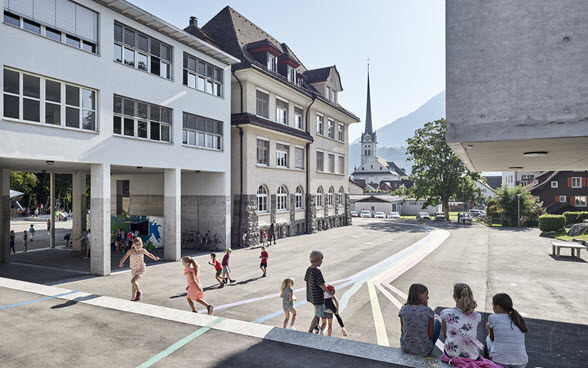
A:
[163, 169, 182, 261]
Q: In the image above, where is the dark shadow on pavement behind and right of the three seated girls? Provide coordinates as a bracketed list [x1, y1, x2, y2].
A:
[435, 307, 588, 368]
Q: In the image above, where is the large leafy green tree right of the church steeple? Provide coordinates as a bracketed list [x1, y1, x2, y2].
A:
[406, 119, 482, 219]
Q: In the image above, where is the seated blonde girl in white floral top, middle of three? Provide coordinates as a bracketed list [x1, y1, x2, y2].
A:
[439, 284, 484, 360]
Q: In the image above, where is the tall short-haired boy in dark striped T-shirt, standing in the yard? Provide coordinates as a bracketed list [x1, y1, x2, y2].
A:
[304, 250, 333, 333]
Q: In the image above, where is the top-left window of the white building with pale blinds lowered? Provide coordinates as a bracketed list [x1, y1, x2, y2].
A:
[4, 0, 98, 54]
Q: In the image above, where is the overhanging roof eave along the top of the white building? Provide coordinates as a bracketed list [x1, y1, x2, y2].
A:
[94, 0, 241, 65]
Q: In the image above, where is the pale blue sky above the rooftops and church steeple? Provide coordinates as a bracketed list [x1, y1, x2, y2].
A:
[130, 0, 445, 142]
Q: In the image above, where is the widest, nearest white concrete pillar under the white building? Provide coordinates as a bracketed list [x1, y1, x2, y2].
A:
[90, 164, 110, 276]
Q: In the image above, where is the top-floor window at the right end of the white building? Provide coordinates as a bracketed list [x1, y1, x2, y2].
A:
[183, 52, 223, 97]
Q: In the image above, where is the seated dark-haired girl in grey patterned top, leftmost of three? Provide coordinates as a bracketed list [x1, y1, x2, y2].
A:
[398, 284, 441, 356]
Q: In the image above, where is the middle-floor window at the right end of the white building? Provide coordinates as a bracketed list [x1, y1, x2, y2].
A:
[182, 112, 223, 150]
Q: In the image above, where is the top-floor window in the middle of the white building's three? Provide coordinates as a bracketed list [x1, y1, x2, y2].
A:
[114, 23, 172, 79]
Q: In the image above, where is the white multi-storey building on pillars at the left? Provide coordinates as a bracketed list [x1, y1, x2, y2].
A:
[0, 0, 238, 275]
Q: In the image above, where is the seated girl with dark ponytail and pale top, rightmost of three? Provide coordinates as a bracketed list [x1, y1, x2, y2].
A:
[486, 294, 529, 368]
